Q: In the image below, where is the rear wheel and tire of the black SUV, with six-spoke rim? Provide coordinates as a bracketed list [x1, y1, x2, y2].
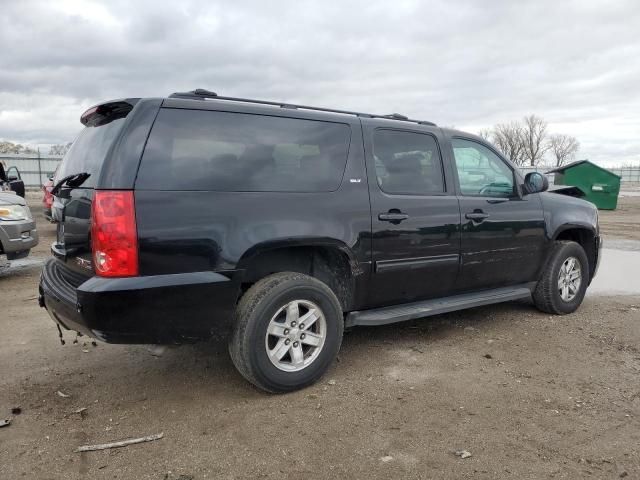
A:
[229, 272, 344, 393]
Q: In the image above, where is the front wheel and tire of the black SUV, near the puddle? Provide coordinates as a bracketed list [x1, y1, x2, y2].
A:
[533, 241, 589, 315]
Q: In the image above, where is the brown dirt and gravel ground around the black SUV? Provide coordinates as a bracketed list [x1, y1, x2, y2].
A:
[0, 193, 640, 480]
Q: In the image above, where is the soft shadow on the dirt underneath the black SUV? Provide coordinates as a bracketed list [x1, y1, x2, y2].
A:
[48, 302, 543, 401]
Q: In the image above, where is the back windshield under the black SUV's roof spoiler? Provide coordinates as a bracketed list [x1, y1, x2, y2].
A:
[54, 118, 125, 188]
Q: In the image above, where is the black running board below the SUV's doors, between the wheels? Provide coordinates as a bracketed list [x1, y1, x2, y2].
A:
[345, 284, 531, 327]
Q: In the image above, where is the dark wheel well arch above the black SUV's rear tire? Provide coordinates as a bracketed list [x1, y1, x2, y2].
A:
[241, 246, 354, 311]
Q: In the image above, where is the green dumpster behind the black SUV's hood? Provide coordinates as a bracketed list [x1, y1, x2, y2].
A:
[547, 160, 620, 210]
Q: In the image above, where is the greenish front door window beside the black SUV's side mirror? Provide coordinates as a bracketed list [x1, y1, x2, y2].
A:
[452, 138, 514, 197]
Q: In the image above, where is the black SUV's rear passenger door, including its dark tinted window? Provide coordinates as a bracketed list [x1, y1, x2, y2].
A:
[364, 123, 460, 306]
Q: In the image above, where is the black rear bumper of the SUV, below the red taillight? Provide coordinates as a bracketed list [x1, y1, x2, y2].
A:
[40, 259, 238, 344]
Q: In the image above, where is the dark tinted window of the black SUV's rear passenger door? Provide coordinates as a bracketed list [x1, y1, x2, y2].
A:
[373, 130, 444, 195]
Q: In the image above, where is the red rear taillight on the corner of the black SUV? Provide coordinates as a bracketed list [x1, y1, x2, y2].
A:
[91, 190, 138, 277]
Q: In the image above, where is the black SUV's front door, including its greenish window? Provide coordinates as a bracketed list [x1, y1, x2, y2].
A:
[451, 138, 545, 291]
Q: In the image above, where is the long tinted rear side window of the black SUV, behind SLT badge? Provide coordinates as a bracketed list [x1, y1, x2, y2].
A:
[136, 109, 351, 192]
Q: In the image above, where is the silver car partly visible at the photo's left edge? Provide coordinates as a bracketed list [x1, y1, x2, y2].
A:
[0, 190, 38, 263]
